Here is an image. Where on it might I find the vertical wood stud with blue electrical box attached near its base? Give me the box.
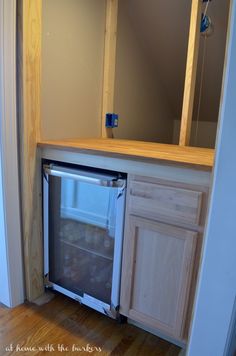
[101,0,118,138]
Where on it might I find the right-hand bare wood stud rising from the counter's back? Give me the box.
[179,0,202,146]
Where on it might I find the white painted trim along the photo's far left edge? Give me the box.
[0,0,24,307]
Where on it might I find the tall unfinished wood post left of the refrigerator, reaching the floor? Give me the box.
[17,0,44,301]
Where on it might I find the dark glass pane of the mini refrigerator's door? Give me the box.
[49,176,117,304]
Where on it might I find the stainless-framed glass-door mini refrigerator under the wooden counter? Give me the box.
[43,162,126,318]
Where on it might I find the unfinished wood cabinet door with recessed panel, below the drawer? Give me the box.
[121,215,197,339]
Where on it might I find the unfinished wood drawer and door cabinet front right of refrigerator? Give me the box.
[120,176,206,341]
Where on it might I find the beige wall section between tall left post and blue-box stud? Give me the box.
[41,0,106,139]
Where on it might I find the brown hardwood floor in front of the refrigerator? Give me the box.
[0,295,180,356]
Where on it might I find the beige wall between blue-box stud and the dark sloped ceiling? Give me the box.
[113,0,173,142]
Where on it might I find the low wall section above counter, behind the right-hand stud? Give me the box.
[172,120,217,148]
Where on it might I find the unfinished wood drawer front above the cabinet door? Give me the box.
[129,180,203,225]
